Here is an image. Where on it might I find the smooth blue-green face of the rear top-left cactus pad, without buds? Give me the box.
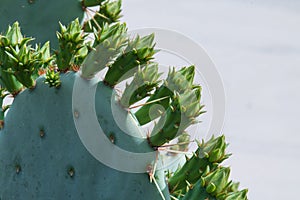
[0,0,84,49]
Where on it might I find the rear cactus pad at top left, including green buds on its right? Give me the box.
[0,0,121,47]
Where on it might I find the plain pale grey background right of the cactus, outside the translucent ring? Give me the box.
[123,0,300,200]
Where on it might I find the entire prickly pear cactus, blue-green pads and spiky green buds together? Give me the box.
[0,0,247,200]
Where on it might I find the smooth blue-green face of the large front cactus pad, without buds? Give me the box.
[0,73,170,200]
